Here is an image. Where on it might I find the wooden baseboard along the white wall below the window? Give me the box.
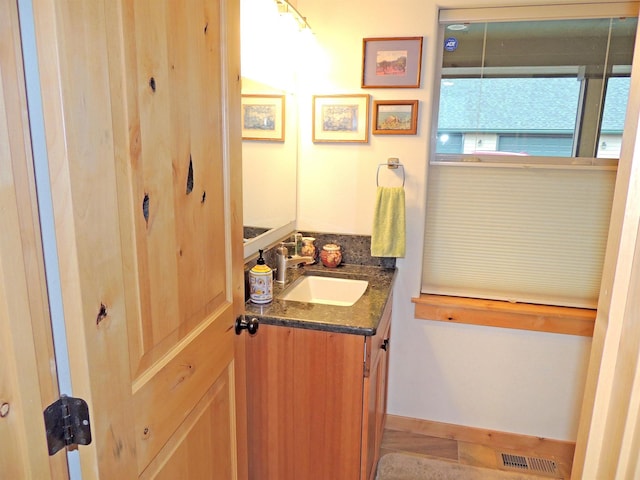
[385,414,575,465]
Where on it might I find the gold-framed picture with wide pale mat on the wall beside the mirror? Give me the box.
[312,94,370,143]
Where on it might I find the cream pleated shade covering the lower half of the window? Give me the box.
[422,162,616,308]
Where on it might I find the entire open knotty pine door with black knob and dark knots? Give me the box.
[33,0,246,479]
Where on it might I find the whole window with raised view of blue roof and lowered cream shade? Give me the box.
[422,4,637,308]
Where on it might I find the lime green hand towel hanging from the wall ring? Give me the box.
[371,187,405,257]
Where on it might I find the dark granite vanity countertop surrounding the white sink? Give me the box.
[245,264,396,335]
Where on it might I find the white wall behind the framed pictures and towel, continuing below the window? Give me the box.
[297,0,608,440]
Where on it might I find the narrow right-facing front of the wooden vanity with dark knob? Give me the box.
[360,301,392,480]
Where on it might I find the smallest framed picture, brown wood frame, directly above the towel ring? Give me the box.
[372,100,418,135]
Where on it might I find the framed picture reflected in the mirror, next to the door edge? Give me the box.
[242,95,285,142]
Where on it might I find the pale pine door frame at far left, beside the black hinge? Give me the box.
[0,0,67,480]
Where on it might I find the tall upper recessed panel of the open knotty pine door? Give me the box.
[125,0,227,375]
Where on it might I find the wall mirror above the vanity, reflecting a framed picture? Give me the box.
[240,0,308,258]
